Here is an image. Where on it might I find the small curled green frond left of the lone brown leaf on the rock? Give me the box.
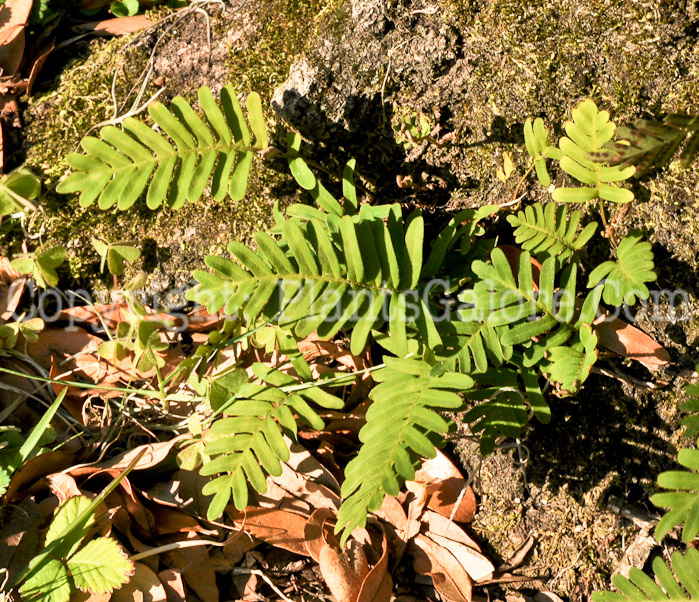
[541,324,597,393]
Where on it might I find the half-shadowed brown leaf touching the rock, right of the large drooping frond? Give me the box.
[414,450,476,523]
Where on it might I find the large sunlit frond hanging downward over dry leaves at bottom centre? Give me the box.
[335,358,473,541]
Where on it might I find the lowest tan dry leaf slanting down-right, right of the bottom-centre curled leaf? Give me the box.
[409,534,473,602]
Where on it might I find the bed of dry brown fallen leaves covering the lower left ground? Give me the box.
[0,247,676,602]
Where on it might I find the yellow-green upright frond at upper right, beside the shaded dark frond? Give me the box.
[553,100,635,203]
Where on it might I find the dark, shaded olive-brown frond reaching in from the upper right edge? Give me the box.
[593,113,699,177]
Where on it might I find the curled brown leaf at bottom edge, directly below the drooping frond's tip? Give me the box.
[318,539,369,602]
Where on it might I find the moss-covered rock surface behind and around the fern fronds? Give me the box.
[12,0,699,601]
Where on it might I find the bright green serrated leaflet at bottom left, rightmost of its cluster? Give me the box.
[68,537,134,594]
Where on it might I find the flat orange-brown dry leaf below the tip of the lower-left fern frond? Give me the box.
[226,505,309,556]
